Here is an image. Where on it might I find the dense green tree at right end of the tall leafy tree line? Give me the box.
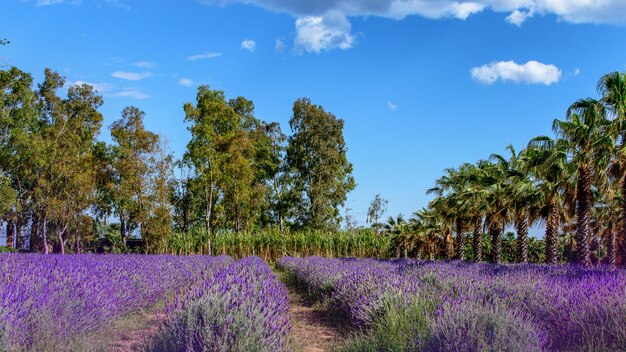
[287,98,356,229]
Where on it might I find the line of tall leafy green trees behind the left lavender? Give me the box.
[0,67,356,254]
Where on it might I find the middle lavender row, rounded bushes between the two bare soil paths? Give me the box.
[149,257,291,352]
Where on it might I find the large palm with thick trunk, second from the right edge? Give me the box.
[553,98,613,265]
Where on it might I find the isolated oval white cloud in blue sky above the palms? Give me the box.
[470,61,562,86]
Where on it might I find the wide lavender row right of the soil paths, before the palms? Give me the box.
[280,257,626,351]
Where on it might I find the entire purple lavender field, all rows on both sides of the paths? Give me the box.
[0,254,626,352]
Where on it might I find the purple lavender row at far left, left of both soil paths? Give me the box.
[0,254,233,351]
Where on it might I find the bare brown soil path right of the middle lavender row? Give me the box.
[276,271,349,352]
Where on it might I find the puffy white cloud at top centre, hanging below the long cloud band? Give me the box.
[294,12,355,53]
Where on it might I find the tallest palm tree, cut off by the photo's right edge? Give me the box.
[598,72,626,264]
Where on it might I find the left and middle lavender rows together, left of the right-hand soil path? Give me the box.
[0,254,290,351]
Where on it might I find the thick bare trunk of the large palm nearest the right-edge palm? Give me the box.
[576,167,591,266]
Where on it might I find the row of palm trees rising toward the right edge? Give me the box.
[388,72,626,266]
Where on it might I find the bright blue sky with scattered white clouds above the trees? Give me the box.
[0,0,626,228]
